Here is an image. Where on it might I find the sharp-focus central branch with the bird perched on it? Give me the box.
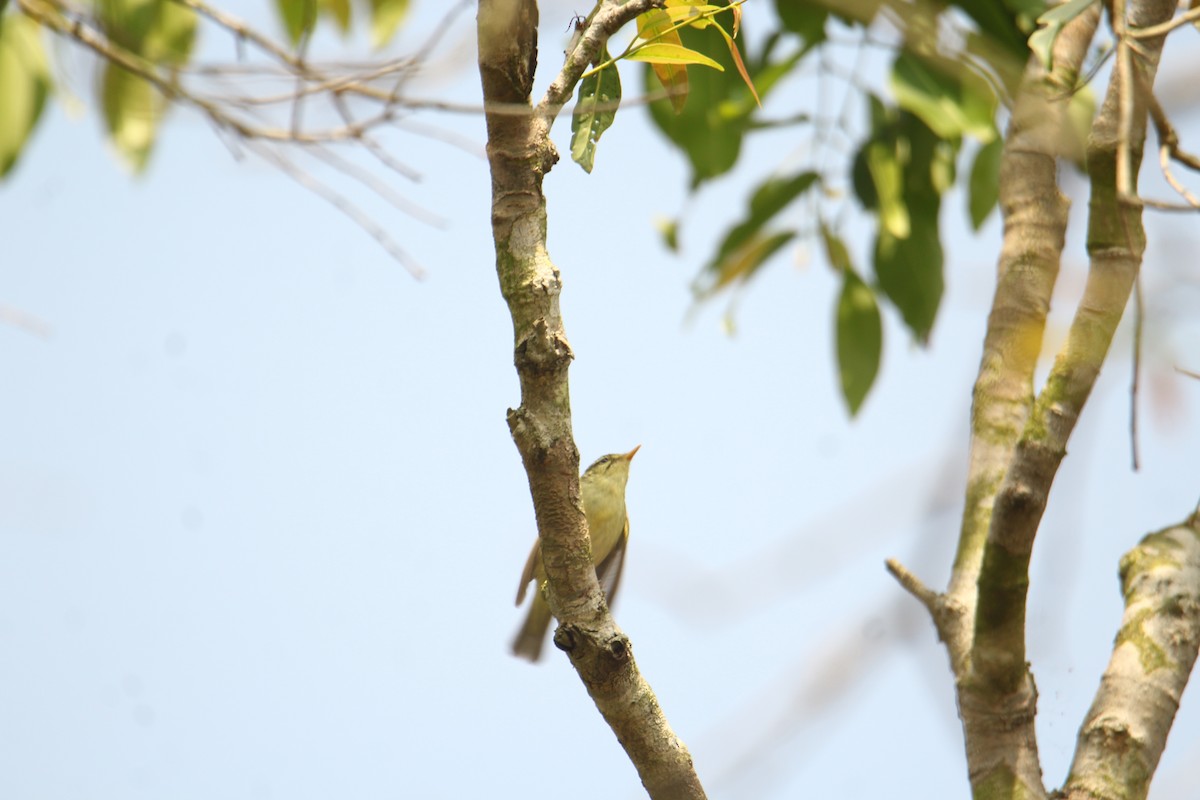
[478,0,704,800]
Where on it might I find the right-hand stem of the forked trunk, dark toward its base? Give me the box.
[973,0,1175,687]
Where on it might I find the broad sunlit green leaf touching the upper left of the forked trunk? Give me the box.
[892,50,997,144]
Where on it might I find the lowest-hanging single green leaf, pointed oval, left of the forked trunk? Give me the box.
[836,269,883,416]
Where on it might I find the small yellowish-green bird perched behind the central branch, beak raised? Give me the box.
[512,445,642,661]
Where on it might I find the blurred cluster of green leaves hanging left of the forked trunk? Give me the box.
[646,0,1060,414]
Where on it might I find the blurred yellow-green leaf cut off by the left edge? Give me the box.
[0,14,52,178]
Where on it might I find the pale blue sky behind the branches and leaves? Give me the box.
[0,0,1200,800]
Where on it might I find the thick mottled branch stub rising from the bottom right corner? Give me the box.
[1063,511,1200,800]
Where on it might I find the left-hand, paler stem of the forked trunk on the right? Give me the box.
[942,6,1100,674]
